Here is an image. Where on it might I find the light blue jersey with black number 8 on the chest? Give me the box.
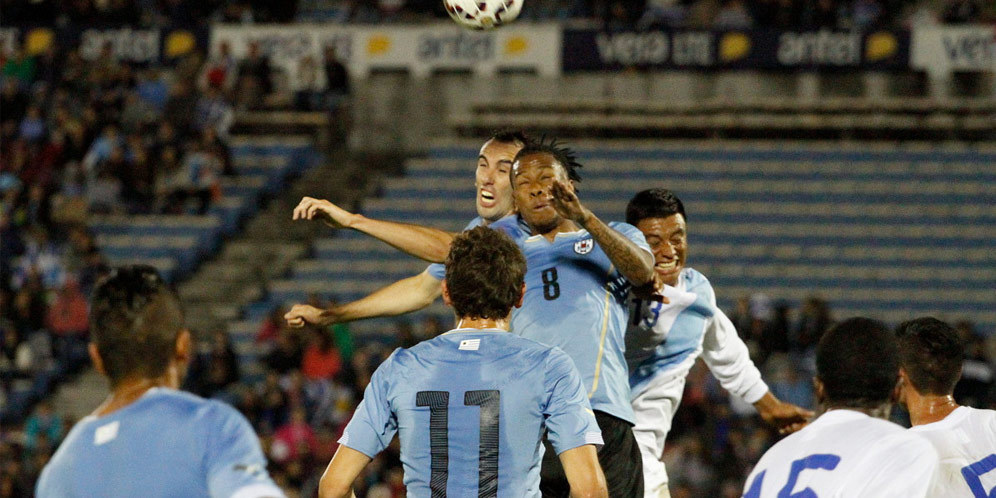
[491,216,650,423]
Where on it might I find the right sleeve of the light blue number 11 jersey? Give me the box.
[543,348,603,455]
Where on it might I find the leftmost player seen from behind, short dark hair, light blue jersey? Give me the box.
[36,265,284,498]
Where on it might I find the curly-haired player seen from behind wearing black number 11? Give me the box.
[319,227,608,498]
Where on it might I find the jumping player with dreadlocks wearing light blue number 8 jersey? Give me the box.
[491,140,654,496]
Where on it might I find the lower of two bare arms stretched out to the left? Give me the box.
[284,271,442,327]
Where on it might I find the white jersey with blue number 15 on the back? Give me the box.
[744,410,937,498]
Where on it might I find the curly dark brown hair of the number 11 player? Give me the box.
[446,227,526,319]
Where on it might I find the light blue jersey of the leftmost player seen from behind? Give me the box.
[36,388,283,498]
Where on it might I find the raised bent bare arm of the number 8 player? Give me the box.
[552,181,654,287]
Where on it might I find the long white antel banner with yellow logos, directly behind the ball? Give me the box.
[211,23,561,86]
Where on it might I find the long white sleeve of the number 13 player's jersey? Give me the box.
[702,308,768,403]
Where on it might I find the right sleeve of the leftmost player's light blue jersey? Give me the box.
[205,402,284,498]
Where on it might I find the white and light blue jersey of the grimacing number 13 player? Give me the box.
[626,268,768,403]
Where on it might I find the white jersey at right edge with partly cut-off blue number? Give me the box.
[910,406,996,498]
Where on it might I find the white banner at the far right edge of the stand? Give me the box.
[910,26,996,73]
